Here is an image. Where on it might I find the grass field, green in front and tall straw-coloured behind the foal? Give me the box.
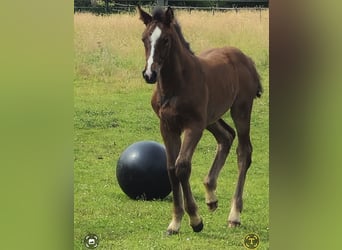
[74,8,269,250]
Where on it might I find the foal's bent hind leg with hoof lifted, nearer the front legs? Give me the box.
[204,119,235,212]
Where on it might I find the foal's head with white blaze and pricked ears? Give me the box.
[138,6,192,83]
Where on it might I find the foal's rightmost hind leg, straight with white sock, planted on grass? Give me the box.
[228,100,253,227]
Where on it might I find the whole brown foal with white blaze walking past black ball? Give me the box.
[138,7,262,234]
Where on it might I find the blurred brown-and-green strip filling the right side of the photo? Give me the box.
[270,0,342,249]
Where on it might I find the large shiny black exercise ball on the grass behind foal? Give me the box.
[116,141,171,200]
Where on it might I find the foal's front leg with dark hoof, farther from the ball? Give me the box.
[175,128,203,232]
